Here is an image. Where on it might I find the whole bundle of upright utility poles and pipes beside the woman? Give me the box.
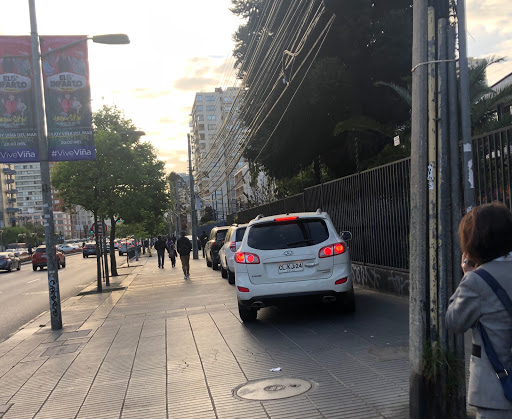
[409,0,466,418]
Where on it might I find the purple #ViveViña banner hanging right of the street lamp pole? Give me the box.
[40,36,96,161]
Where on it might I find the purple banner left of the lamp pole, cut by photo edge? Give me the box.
[0,36,39,163]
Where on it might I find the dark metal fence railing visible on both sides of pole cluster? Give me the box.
[228,126,512,270]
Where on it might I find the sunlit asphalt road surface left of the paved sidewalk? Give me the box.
[0,253,102,342]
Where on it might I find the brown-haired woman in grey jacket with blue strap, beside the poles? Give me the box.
[446,203,512,419]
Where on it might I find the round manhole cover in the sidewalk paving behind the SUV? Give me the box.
[233,377,313,401]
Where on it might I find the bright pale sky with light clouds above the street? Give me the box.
[0,0,512,173]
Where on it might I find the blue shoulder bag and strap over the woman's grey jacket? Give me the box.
[474,269,512,402]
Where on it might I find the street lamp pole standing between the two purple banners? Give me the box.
[28,0,62,330]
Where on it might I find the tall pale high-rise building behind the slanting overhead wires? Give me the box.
[190,87,243,219]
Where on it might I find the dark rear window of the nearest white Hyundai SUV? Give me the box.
[247,218,329,250]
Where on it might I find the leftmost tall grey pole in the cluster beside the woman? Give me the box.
[409,0,428,418]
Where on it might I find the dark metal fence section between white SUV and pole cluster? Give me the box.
[229,159,410,269]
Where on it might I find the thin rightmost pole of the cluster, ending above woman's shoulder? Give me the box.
[457,0,475,213]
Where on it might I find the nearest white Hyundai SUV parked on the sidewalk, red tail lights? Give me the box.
[235,210,355,321]
